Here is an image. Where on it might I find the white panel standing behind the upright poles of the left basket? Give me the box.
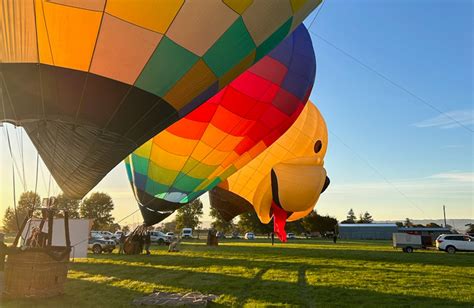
[21,218,92,258]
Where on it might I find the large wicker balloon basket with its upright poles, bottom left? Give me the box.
[3,210,71,298]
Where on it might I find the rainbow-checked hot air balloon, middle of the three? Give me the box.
[126,25,316,225]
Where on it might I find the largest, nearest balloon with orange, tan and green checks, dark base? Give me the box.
[0,0,320,198]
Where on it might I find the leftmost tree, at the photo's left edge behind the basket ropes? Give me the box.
[3,191,41,232]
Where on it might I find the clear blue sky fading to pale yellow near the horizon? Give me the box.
[0,0,474,223]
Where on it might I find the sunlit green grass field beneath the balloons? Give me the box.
[0,240,474,307]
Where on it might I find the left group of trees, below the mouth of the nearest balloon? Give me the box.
[3,191,115,232]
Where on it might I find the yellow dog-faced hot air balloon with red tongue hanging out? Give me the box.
[209,103,329,241]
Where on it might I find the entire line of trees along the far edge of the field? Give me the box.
[3,191,344,234]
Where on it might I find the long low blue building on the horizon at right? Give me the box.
[339,223,398,240]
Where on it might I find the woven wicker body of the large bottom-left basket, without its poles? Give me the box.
[4,247,69,298]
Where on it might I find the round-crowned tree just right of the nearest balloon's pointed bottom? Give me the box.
[79,192,114,230]
